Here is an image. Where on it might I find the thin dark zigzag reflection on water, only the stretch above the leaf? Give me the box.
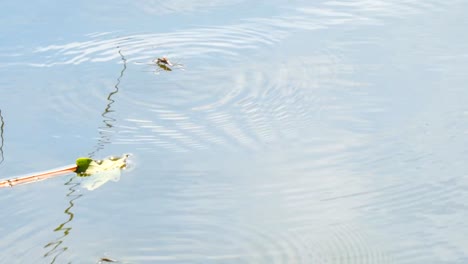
[88,49,127,157]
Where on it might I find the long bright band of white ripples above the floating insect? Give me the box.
[30,1,454,66]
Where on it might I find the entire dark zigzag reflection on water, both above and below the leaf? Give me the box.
[43,47,127,264]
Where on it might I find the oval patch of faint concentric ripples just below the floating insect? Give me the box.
[110,55,348,151]
